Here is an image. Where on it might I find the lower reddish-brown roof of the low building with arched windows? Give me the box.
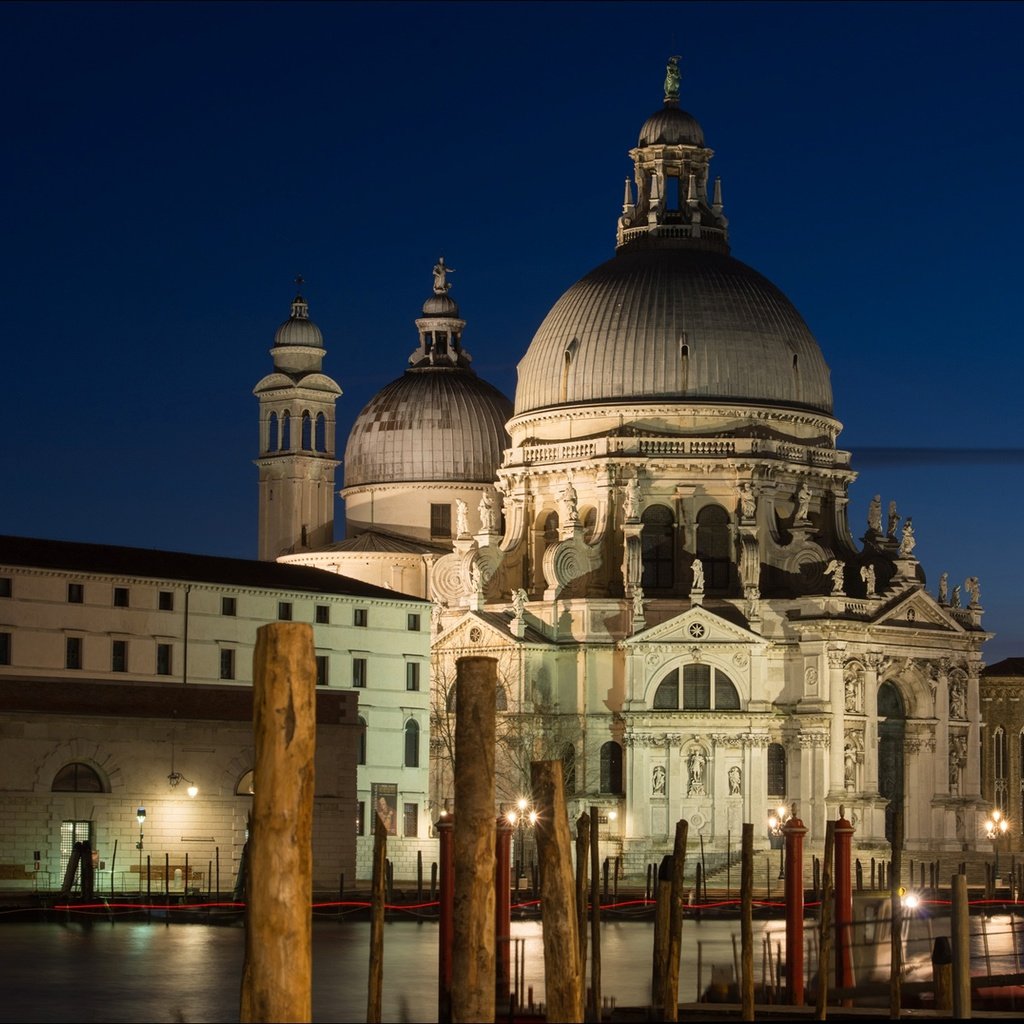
[0,676,358,725]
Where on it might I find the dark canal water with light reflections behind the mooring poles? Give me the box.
[0,916,1021,1022]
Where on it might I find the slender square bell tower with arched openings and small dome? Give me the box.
[253,278,341,560]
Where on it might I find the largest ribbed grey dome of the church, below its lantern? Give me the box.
[515,245,833,415]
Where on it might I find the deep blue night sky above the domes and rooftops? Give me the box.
[0,3,1024,662]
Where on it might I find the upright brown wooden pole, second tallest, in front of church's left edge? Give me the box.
[452,657,498,1024]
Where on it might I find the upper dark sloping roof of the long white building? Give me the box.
[0,536,422,601]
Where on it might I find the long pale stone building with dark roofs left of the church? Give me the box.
[0,537,430,891]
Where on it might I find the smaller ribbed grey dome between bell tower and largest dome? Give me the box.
[344,366,512,487]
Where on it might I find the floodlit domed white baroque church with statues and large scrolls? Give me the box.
[285,63,987,870]
